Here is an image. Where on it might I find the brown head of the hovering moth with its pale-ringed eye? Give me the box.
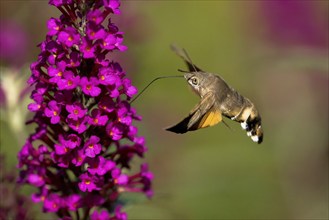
[184,72,213,97]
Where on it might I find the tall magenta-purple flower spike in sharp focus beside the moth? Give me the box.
[18,0,153,220]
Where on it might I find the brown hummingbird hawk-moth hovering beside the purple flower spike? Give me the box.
[166,46,263,144]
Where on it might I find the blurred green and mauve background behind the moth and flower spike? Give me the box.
[0,0,329,219]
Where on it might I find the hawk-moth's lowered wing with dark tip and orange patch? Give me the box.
[166,93,222,134]
